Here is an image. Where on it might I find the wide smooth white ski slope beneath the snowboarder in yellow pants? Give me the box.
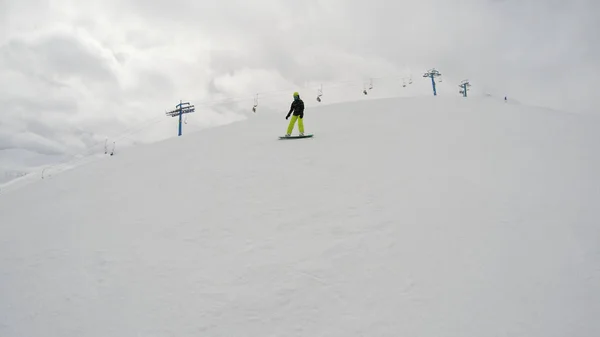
[0,97,600,337]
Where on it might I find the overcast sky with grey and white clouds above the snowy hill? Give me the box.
[0,0,600,182]
